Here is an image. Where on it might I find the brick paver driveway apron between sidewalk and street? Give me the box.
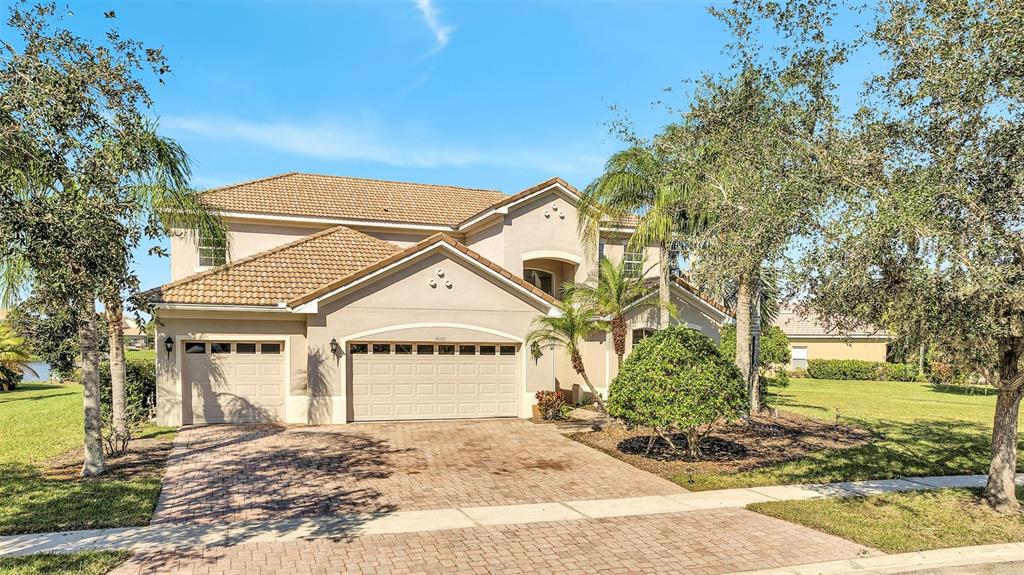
[111,510,878,575]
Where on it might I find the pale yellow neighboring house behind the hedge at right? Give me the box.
[775,306,891,369]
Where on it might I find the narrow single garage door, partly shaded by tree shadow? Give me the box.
[181,341,285,424]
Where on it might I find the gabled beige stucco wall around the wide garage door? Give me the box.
[306,250,551,423]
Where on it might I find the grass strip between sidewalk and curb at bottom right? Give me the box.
[748,488,1024,554]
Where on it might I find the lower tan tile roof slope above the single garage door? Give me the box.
[144,226,398,306]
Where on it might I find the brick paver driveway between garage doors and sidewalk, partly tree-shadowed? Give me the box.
[153,419,684,524]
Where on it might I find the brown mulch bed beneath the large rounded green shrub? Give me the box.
[568,413,872,478]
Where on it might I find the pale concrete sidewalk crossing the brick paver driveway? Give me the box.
[0,475,1024,557]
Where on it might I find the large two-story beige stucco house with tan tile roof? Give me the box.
[150,174,728,426]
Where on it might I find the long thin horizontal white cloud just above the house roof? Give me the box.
[161,117,604,175]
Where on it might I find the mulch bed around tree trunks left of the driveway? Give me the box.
[43,437,174,481]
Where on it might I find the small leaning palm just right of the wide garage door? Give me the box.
[526,292,607,412]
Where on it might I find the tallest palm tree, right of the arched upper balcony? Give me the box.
[577,145,694,327]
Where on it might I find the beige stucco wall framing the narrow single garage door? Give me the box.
[149,309,306,426]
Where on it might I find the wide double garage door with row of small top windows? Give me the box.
[348,342,520,422]
